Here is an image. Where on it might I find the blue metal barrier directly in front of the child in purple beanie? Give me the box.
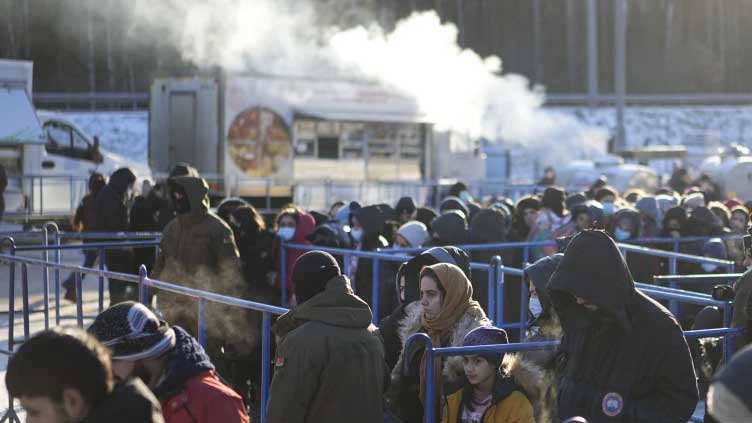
[404,327,739,423]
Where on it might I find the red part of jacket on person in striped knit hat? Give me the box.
[162,371,250,423]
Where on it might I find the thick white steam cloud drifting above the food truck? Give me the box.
[132,0,607,167]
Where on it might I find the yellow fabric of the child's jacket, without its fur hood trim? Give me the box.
[441,389,535,423]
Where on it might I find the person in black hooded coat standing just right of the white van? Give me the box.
[95,168,138,304]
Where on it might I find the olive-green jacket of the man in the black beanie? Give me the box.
[267,276,388,423]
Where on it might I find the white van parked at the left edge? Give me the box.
[0,60,151,220]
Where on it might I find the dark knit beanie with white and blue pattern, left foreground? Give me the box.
[89,301,175,361]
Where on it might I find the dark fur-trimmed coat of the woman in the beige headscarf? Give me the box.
[386,304,491,423]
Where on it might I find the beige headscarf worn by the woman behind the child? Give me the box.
[420,263,479,404]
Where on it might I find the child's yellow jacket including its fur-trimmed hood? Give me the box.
[441,354,542,423]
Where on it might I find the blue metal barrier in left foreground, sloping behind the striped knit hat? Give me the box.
[0,254,288,423]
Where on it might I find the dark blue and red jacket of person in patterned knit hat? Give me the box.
[154,326,249,423]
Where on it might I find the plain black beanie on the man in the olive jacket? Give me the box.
[292,251,342,304]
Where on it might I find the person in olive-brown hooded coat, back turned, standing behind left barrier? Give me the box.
[154,176,253,380]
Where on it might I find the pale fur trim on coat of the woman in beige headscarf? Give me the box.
[392,301,491,383]
